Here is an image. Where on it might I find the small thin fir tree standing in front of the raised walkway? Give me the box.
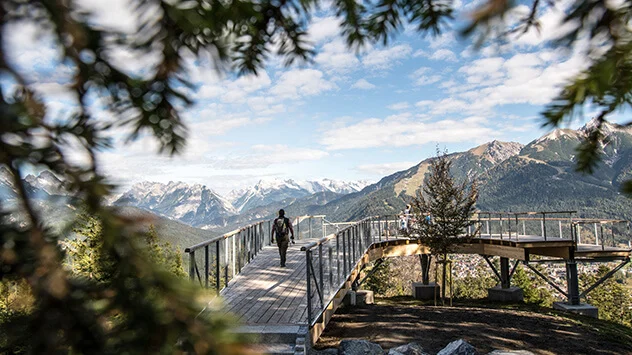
[408,151,478,301]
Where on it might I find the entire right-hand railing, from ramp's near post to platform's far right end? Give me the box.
[301,211,632,326]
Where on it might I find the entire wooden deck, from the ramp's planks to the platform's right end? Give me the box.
[215,235,630,332]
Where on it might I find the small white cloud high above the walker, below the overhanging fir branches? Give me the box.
[270,69,338,99]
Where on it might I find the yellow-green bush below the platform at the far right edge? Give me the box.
[579,265,632,327]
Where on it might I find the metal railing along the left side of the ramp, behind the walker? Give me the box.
[184,215,325,293]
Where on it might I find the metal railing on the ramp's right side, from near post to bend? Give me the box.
[301,216,399,325]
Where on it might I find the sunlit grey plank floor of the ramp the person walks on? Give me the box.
[221,238,318,325]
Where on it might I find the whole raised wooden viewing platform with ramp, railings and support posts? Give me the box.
[186,211,632,350]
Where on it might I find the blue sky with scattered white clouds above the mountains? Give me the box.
[0,0,623,194]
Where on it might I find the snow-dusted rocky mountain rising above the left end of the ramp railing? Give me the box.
[114,181,237,228]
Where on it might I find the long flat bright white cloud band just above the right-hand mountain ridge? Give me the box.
[320,116,495,150]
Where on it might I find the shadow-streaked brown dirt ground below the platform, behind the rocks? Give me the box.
[315,298,632,355]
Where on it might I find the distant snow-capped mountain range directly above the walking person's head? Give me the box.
[230,179,368,212]
